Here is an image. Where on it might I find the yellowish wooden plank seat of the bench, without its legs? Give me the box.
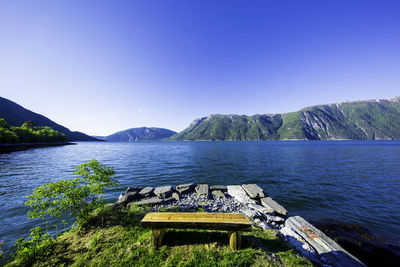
[141,212,252,231]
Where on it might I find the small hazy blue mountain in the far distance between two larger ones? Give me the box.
[106,127,176,142]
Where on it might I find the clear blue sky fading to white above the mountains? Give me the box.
[0,0,400,135]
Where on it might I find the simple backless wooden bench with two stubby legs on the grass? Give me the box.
[141,212,252,250]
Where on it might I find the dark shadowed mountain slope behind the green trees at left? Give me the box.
[0,97,97,141]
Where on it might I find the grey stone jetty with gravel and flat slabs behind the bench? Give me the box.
[115,183,365,266]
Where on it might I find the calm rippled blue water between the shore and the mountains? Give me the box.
[0,141,400,256]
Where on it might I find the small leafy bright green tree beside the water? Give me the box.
[25,159,117,223]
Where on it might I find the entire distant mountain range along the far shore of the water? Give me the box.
[0,97,400,142]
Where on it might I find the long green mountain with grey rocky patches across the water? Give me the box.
[170,97,400,140]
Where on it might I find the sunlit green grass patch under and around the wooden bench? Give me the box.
[6,206,311,267]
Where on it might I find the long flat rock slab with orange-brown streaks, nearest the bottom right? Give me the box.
[281,216,365,266]
